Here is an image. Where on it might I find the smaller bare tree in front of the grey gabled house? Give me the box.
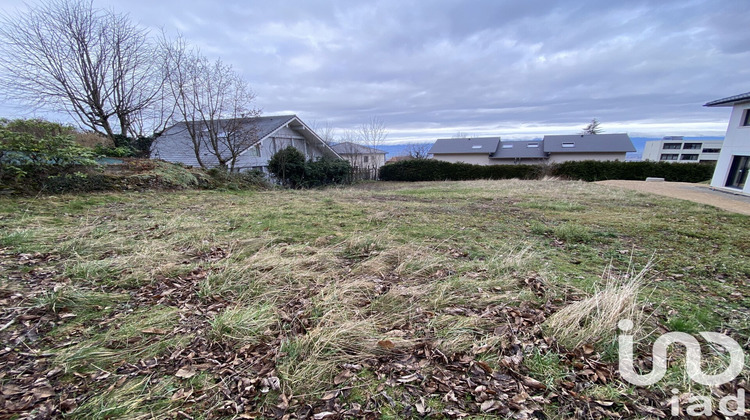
[163,38,260,171]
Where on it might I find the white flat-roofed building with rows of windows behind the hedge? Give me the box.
[642,136,724,163]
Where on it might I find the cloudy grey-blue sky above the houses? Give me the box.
[0,0,750,143]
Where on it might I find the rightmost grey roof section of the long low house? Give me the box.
[544,133,635,153]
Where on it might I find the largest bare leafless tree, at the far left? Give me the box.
[0,0,163,138]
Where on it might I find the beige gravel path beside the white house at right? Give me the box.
[597,180,750,216]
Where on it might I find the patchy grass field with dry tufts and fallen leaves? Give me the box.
[0,180,750,419]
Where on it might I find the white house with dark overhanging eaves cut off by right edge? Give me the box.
[705,92,750,194]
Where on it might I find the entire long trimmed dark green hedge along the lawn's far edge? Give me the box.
[380,159,715,182]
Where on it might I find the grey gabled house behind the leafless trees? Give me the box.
[151,115,341,172]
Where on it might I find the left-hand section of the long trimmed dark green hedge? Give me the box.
[380,159,544,181]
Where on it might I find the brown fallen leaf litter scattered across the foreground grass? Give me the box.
[0,206,745,419]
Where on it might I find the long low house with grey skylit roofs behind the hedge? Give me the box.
[429,134,635,165]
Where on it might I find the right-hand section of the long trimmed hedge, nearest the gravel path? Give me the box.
[552,160,716,182]
